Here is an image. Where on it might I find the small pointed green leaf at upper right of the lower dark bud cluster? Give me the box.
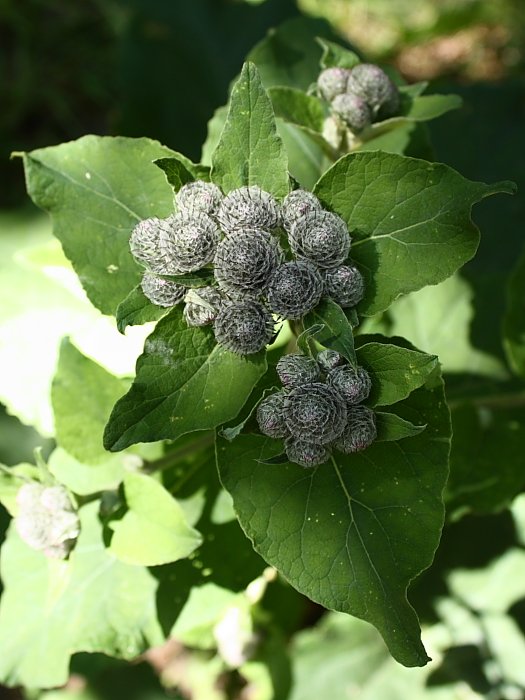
[356,336,438,406]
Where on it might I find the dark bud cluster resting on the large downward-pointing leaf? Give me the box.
[257,350,377,467]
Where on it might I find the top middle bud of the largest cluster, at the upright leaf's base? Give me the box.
[217,185,280,234]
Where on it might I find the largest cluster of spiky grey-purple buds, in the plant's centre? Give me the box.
[130,180,364,355]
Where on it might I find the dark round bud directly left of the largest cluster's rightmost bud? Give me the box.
[267,260,323,320]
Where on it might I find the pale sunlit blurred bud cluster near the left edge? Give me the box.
[15,482,80,559]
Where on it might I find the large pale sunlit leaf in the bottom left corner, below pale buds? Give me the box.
[0,503,164,688]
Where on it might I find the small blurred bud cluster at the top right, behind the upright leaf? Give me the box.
[317,63,400,140]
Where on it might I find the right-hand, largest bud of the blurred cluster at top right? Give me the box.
[346,63,399,120]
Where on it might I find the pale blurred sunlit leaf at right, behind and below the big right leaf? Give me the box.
[385,275,507,379]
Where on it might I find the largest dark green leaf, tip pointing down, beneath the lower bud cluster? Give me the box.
[217,366,450,666]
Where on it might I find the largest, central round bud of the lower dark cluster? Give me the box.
[283,382,346,445]
